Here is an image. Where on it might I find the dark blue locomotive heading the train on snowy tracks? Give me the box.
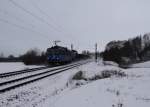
[46,45,77,64]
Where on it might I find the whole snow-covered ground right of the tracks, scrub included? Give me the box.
[0,61,150,107]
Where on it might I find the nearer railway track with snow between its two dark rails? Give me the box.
[0,61,90,93]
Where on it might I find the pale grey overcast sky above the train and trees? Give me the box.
[0,0,150,55]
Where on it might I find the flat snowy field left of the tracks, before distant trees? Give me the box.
[0,62,44,73]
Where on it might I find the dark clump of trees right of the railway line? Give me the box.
[101,36,150,64]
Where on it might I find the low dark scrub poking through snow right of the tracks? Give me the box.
[66,70,126,88]
